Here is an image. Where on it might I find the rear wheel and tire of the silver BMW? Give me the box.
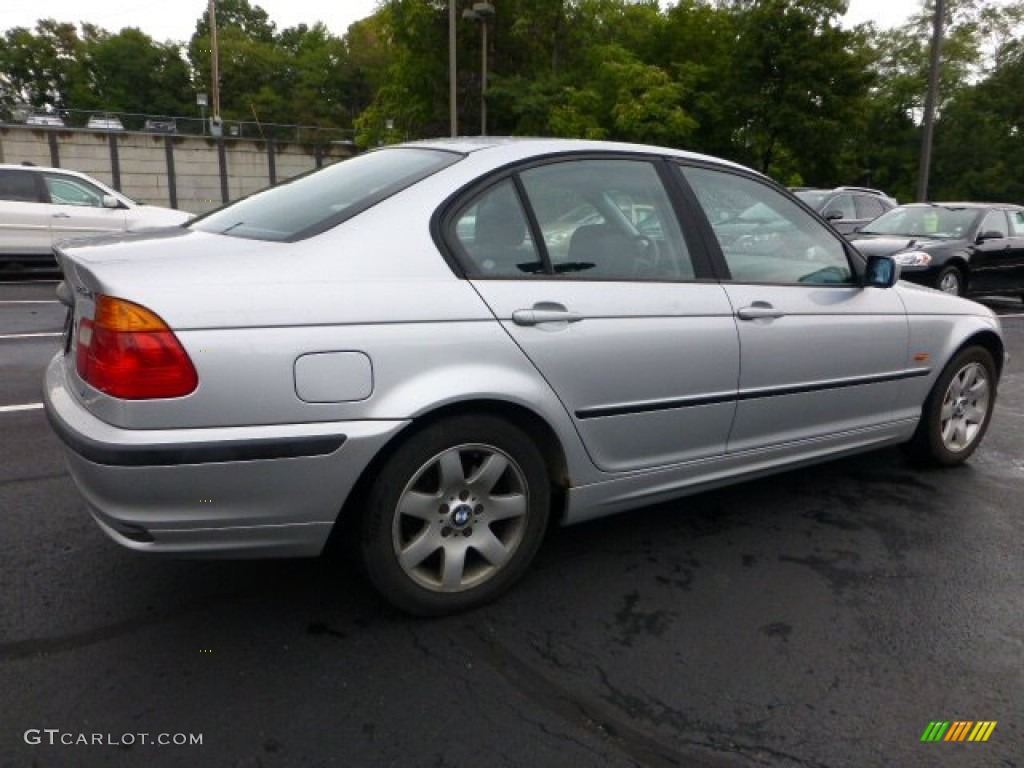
[360,415,551,616]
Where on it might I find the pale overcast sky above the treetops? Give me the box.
[0,0,923,42]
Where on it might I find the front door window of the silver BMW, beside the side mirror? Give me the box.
[682,167,855,285]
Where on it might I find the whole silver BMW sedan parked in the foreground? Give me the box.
[45,138,1004,614]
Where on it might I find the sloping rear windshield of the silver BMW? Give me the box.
[188,147,463,243]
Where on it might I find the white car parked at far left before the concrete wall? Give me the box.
[0,165,191,271]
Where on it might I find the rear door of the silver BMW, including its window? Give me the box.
[447,157,739,471]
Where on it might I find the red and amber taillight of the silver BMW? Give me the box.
[75,296,199,400]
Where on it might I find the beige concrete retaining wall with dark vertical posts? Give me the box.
[0,125,352,213]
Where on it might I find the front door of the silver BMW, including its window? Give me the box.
[680,166,909,453]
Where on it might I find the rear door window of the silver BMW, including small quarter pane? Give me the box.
[453,158,694,281]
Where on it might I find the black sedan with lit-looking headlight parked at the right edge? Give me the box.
[851,203,1024,298]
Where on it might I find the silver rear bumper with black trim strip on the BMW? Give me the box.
[44,354,406,557]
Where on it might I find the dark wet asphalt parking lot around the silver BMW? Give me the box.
[0,282,1024,768]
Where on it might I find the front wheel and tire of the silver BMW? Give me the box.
[906,346,996,467]
